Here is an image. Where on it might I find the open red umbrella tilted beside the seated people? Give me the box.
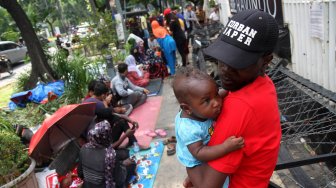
[29,103,96,161]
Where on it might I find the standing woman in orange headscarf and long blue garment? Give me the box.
[151,21,176,75]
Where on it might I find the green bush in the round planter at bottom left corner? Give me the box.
[0,129,30,185]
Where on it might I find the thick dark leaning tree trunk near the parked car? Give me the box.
[0,0,55,89]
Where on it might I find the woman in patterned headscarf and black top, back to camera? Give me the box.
[78,120,135,188]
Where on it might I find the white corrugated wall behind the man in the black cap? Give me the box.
[218,0,336,92]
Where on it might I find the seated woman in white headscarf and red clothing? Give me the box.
[125,55,149,87]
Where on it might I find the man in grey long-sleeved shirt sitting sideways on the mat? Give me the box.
[111,63,149,109]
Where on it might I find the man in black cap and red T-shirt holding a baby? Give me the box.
[188,9,281,188]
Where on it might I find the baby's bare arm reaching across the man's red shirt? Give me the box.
[188,136,244,162]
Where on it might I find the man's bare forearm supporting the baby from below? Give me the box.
[187,163,228,188]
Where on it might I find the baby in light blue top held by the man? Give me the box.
[173,67,244,185]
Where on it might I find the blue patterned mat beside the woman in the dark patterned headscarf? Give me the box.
[129,141,164,188]
